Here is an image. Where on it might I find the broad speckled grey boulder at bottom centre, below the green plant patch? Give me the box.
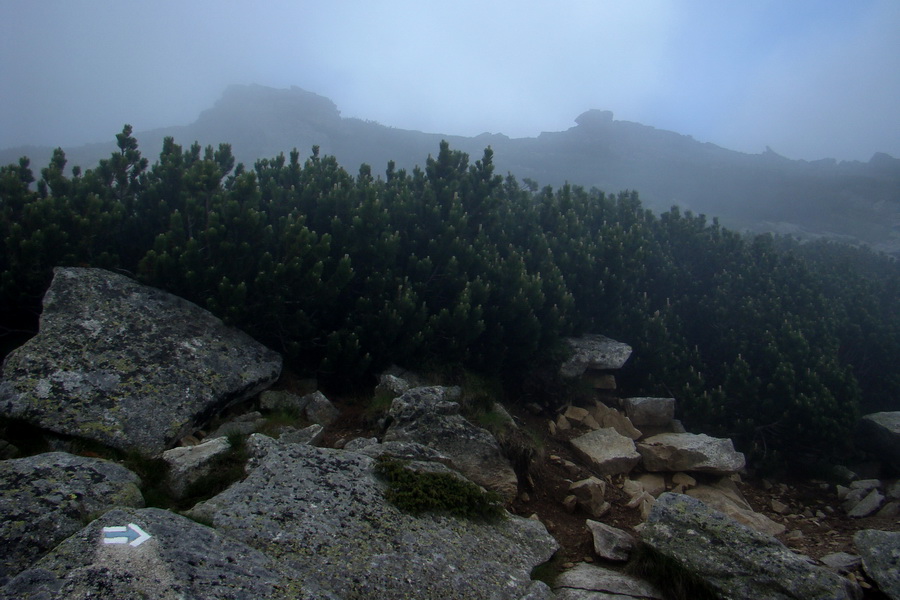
[192,435,558,600]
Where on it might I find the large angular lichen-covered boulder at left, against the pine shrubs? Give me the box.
[0,268,281,455]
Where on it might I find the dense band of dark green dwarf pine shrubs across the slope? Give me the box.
[0,126,900,458]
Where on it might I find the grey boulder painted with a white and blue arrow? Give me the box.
[0,508,302,600]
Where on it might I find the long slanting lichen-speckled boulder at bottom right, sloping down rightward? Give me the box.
[641,493,858,600]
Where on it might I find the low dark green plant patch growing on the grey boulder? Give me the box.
[375,457,504,520]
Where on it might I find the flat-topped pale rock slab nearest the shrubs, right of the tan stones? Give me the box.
[637,433,744,475]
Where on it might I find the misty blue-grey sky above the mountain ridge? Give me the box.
[0,0,900,160]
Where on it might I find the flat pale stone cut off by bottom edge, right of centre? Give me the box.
[553,563,664,600]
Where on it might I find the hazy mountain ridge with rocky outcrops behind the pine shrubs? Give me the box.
[0,85,900,255]
